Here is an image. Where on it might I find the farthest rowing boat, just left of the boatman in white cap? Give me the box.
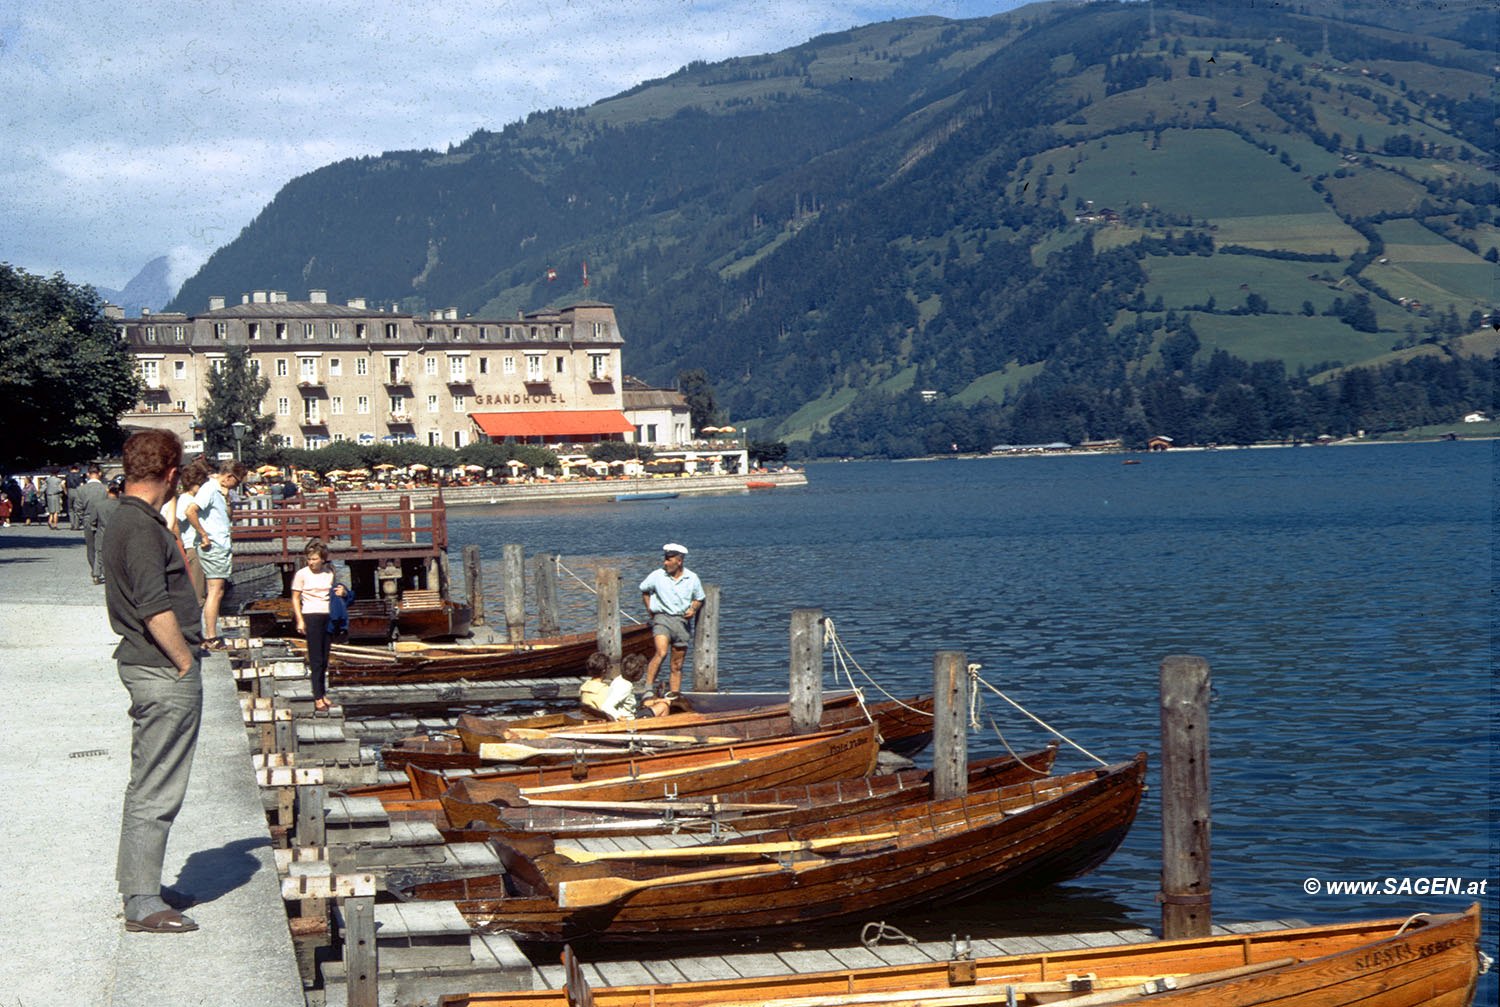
[329,626,654,686]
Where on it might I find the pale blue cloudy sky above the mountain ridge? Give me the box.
[0,0,1020,295]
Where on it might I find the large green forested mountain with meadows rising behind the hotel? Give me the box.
[171,0,1500,450]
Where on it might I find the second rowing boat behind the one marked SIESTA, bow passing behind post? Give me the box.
[440,741,1058,842]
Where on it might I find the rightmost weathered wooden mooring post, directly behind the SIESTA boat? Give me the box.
[1157,654,1214,939]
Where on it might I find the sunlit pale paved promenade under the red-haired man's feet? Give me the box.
[0,522,305,1007]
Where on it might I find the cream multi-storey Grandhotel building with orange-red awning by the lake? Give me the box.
[108,290,692,447]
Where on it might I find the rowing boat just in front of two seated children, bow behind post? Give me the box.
[381,695,933,768]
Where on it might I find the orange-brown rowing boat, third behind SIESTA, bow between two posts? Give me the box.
[344,725,878,816]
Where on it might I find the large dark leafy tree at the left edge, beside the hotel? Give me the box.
[0,263,141,468]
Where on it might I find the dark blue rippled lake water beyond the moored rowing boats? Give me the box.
[450,443,1500,978]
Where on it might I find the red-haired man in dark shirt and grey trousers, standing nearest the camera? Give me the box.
[101,429,203,933]
